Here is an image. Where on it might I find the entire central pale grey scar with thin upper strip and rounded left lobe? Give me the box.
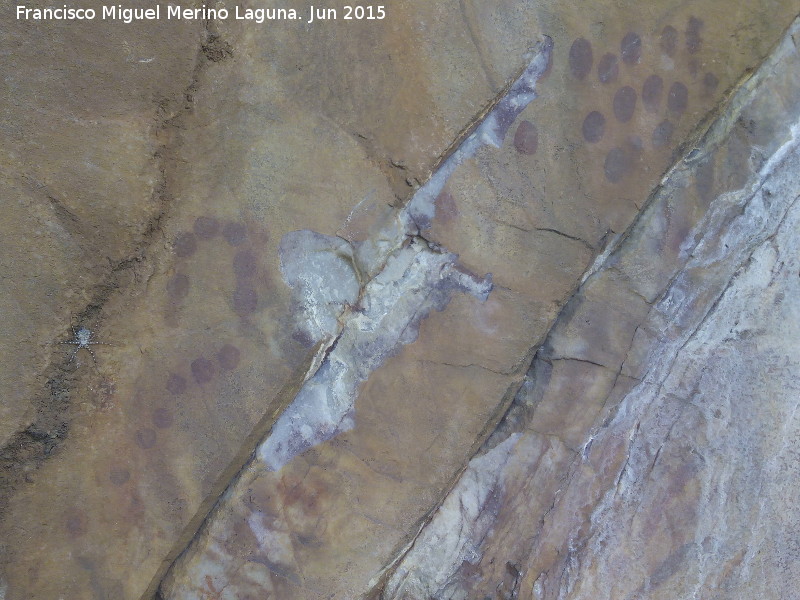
[266,38,553,470]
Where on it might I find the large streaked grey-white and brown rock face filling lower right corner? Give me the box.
[381,16,800,599]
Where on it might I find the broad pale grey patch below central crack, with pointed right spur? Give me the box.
[257,240,492,470]
